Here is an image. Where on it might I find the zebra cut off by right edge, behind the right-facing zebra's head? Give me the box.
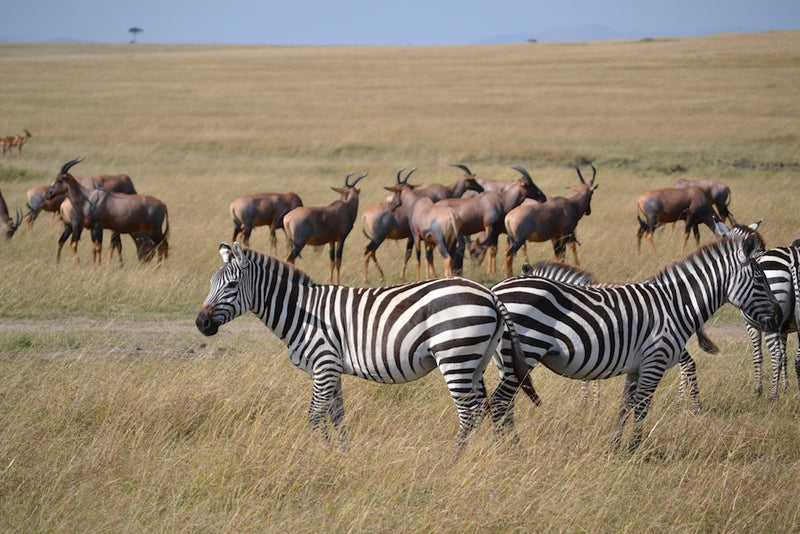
[742,246,800,400]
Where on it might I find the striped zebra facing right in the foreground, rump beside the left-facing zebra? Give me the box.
[491,225,780,448]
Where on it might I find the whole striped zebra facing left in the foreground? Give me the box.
[196,243,526,450]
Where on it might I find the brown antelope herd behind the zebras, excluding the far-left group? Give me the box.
[225,163,735,284]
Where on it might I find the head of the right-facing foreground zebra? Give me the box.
[727,230,783,332]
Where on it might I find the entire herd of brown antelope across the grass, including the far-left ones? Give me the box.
[0,153,735,276]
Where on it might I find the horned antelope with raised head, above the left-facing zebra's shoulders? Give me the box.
[283,172,367,284]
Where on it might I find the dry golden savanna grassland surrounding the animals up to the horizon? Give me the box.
[0,32,800,533]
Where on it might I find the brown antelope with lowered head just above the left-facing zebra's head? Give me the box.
[230,192,303,251]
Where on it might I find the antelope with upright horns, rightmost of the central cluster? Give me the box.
[503,165,597,276]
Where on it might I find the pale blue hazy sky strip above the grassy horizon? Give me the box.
[0,0,800,45]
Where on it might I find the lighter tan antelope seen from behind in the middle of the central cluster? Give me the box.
[385,181,460,281]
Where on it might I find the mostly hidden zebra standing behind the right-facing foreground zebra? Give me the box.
[522,260,719,413]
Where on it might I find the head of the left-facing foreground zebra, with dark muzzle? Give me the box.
[195,242,252,336]
